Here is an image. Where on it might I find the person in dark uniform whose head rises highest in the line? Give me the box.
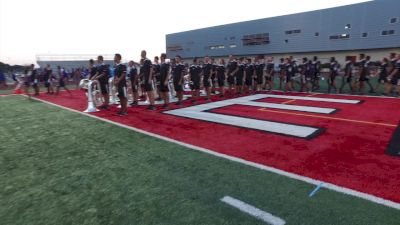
[140,50,156,110]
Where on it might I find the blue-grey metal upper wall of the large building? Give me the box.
[166,0,400,58]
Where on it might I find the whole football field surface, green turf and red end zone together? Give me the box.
[0,92,400,225]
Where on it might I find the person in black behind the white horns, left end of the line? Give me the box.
[92,55,110,109]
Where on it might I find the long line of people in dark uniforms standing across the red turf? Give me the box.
[89,51,400,115]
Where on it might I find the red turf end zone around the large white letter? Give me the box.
[35,92,400,203]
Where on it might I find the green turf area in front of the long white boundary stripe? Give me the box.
[0,96,400,225]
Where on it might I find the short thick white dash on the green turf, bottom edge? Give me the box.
[221,196,286,225]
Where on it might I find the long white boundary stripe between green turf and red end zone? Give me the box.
[32,97,400,210]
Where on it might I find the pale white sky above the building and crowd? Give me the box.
[0,0,366,64]
